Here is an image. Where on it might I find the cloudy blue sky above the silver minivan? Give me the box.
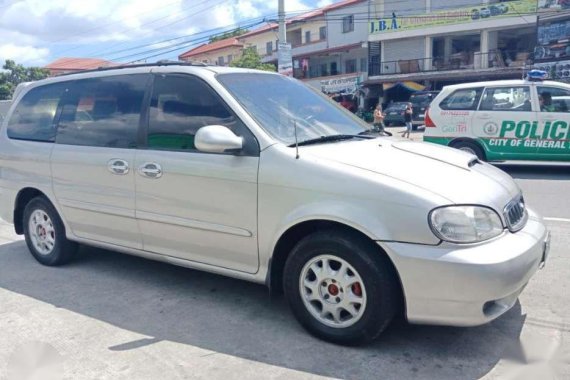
[0,0,338,66]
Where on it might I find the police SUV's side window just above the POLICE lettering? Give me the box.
[479,86,532,112]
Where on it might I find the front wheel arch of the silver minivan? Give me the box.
[267,219,406,312]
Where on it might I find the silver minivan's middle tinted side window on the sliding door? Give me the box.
[56,74,148,148]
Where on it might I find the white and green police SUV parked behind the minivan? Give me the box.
[424,71,570,161]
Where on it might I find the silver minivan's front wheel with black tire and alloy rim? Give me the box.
[283,229,400,345]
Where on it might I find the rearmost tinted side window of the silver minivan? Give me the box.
[8,82,69,142]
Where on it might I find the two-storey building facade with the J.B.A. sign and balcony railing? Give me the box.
[367,0,537,100]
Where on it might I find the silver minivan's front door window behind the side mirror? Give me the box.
[147,75,259,155]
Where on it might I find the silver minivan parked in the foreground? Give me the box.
[0,63,549,344]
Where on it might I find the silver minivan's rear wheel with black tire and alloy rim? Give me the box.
[23,197,77,266]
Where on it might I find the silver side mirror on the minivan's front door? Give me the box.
[194,125,243,153]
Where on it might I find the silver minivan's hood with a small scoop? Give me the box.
[300,138,520,208]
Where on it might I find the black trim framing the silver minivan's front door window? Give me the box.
[137,72,261,157]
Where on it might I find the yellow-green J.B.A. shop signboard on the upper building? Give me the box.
[369,0,537,34]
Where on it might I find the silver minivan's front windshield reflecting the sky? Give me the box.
[217,73,369,145]
